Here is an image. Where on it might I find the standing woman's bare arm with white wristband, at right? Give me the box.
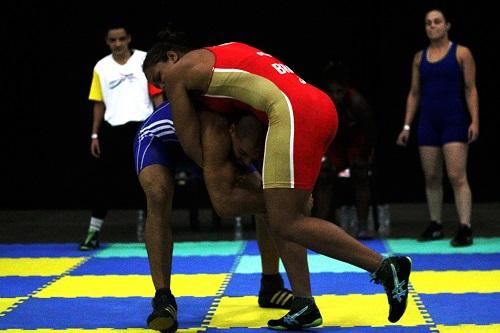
[397,51,423,146]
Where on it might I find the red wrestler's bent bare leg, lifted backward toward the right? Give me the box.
[264,188,382,272]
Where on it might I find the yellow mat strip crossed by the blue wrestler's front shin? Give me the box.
[33,274,227,298]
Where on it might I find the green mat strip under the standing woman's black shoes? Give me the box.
[385,237,500,254]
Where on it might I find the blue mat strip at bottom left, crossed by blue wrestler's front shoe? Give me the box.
[0,297,213,329]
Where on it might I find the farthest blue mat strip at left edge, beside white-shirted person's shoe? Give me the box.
[0,243,91,258]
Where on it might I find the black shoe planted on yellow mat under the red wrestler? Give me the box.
[267,297,323,331]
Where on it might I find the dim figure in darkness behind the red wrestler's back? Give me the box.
[315,61,376,239]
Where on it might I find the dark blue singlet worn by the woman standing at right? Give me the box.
[418,43,470,147]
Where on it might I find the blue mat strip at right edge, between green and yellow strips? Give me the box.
[410,254,500,272]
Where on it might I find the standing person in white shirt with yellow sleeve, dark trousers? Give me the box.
[79,24,163,251]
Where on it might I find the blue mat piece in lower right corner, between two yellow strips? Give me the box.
[420,293,500,325]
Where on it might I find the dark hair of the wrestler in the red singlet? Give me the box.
[142,25,192,70]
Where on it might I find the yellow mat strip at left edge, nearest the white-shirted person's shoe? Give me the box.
[0,258,86,276]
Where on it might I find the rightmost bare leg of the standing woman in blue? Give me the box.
[443,142,472,226]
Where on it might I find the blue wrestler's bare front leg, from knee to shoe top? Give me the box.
[139,165,174,290]
